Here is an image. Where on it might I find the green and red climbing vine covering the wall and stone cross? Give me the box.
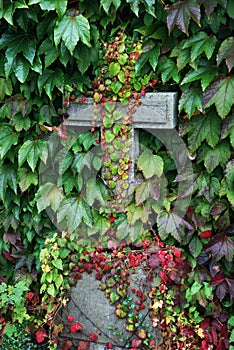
[0,0,234,350]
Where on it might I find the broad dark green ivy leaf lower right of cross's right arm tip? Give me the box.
[183,111,221,152]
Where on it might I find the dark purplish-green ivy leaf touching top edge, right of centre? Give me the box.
[167,0,201,35]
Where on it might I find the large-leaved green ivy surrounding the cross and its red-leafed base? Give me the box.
[0,0,234,350]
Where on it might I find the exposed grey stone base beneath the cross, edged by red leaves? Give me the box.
[55,268,161,350]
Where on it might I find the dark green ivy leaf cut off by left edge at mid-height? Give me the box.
[0,164,17,201]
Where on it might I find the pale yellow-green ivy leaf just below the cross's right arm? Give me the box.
[137,150,163,179]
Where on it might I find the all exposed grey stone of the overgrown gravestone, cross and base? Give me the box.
[55,92,177,350]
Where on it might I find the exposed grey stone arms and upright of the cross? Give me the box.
[65,92,177,208]
